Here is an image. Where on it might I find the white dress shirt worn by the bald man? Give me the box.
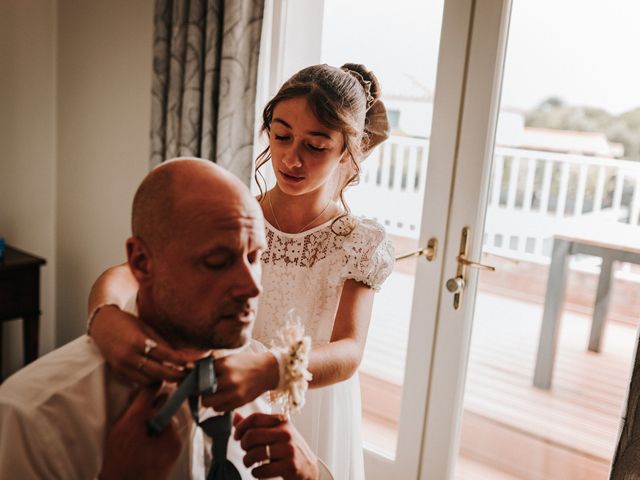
[0,296,269,480]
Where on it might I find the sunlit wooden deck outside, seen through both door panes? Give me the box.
[362,275,636,480]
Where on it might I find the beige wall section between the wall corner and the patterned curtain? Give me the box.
[56,0,153,344]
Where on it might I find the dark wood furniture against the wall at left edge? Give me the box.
[0,245,46,376]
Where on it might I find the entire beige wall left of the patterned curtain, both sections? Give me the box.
[0,0,153,375]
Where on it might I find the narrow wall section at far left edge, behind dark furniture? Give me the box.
[0,0,56,375]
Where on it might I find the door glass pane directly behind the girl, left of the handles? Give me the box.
[322,0,443,457]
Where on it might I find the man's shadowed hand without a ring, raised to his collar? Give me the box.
[99,387,182,480]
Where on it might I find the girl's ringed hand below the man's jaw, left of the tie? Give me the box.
[90,305,187,385]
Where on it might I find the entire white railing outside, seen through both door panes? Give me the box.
[347,137,640,279]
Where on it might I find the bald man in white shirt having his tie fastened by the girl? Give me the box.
[0,159,322,480]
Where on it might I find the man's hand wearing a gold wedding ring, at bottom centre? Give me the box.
[233,413,319,480]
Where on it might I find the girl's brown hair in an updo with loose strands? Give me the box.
[255,63,389,223]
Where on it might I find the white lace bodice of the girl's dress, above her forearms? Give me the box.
[253,216,393,345]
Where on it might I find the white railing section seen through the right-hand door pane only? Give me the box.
[484,148,640,261]
